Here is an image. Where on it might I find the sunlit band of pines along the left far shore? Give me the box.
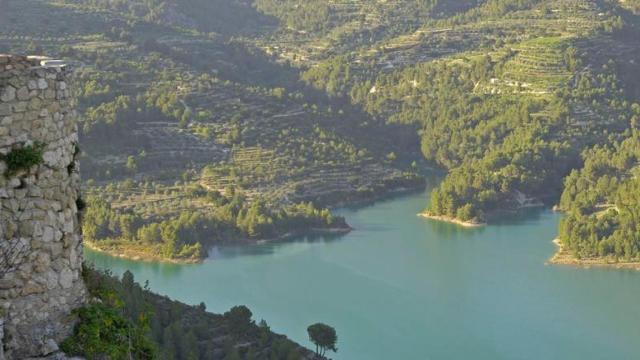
[82,188,349,261]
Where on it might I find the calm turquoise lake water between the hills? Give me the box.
[86,190,640,360]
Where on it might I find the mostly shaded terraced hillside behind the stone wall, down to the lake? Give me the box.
[0,0,423,262]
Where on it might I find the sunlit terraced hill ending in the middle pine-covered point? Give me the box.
[276,0,638,226]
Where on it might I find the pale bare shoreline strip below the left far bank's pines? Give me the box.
[82,225,353,265]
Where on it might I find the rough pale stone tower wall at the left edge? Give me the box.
[0,55,86,359]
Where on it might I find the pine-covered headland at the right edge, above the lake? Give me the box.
[560,133,640,261]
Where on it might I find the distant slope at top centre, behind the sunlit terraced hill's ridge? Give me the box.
[255,0,481,66]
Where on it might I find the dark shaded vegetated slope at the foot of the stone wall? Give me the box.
[62,268,323,360]
